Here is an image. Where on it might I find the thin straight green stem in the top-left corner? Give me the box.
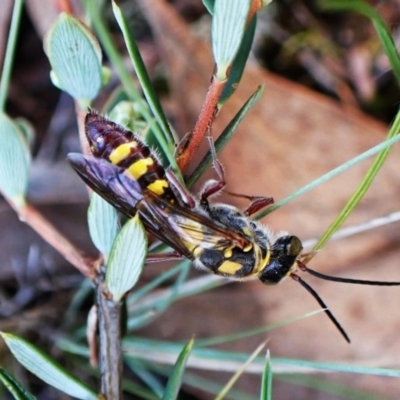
[0,0,24,112]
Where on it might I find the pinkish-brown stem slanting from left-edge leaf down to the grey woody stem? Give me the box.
[14,202,96,279]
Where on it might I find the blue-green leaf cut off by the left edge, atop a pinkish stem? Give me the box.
[0,113,31,208]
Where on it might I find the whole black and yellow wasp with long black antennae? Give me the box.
[68,110,400,341]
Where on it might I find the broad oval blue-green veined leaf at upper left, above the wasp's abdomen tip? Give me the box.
[44,13,103,104]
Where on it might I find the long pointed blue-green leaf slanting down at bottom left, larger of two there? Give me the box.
[1,332,97,400]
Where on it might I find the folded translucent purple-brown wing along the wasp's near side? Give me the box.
[68,153,249,259]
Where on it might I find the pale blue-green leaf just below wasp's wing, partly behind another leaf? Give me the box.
[88,193,118,261]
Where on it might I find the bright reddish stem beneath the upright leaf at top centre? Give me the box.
[177,76,226,173]
